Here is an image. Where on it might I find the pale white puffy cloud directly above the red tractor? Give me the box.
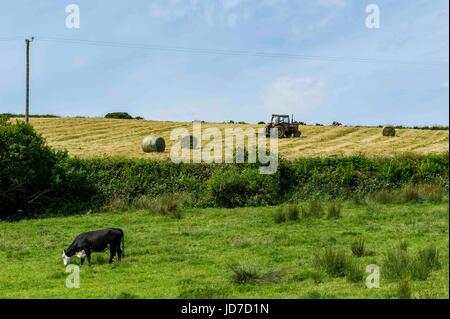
[263,77,325,116]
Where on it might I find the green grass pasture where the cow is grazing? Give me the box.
[0,203,449,298]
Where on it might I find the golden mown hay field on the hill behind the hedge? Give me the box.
[26,118,449,159]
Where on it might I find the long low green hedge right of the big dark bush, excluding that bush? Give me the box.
[68,154,449,212]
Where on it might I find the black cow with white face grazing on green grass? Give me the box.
[62,228,125,266]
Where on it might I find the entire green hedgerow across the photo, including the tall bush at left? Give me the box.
[0,121,449,219]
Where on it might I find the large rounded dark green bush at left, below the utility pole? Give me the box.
[0,118,91,219]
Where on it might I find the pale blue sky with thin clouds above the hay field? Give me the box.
[0,0,449,125]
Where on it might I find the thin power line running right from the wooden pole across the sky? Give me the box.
[30,36,448,66]
